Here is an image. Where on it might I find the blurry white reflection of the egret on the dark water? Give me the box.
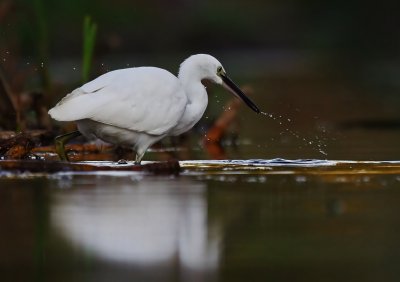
[51,177,220,281]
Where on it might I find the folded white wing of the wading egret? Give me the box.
[49,67,187,135]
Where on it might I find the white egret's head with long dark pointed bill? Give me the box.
[179,54,261,113]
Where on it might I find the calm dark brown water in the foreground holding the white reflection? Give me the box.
[0,159,400,281]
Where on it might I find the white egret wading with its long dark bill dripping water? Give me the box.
[49,54,260,164]
